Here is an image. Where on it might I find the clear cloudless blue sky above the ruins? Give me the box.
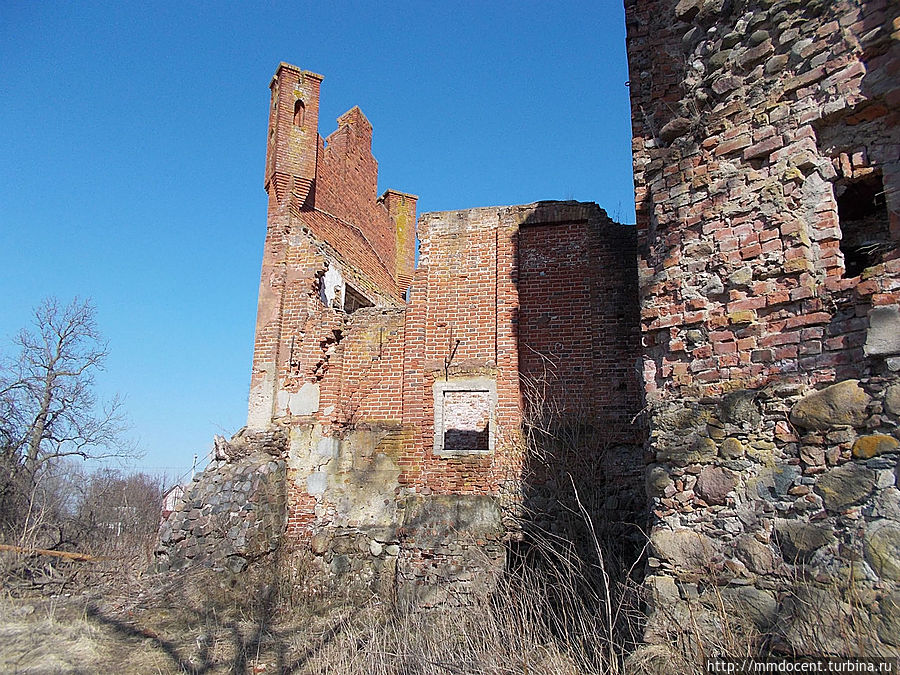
[0,0,634,478]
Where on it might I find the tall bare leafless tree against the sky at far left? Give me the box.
[0,298,135,540]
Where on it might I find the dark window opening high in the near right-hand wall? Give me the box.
[834,171,896,277]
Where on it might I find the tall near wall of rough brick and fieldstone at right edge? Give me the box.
[625,0,900,655]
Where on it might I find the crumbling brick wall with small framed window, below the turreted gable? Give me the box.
[275,202,640,602]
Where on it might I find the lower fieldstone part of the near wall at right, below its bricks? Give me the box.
[645,378,900,654]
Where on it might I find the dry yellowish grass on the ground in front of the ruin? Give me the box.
[0,532,648,675]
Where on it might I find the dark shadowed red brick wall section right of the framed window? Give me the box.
[518,219,641,440]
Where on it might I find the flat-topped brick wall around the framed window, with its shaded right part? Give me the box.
[404,202,640,494]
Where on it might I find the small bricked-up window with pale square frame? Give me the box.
[434,377,497,455]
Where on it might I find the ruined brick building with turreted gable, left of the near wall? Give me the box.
[156,63,640,602]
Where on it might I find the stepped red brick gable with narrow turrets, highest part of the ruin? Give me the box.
[248,64,416,428]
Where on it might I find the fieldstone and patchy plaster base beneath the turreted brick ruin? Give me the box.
[154,425,506,608]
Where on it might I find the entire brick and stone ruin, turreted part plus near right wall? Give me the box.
[161,0,900,654]
